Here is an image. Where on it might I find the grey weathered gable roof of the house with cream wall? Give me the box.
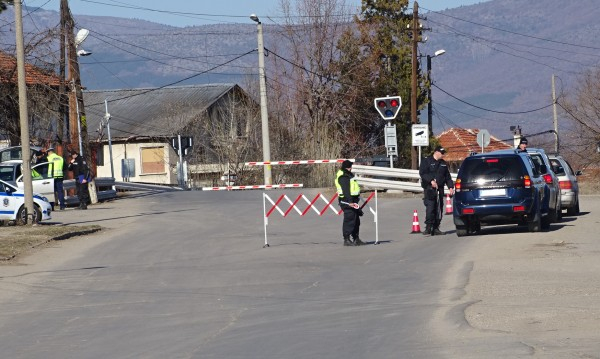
[83,84,244,140]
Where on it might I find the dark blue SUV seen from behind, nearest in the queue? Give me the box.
[453,150,547,237]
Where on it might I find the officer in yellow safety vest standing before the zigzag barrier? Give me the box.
[335,160,365,246]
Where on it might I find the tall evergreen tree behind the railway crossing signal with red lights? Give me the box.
[338,0,426,167]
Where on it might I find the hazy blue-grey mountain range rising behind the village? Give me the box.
[0,0,600,143]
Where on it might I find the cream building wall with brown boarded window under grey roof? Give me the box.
[96,142,178,185]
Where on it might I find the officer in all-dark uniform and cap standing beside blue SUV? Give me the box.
[419,146,454,235]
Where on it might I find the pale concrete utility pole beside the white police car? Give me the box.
[14,1,35,224]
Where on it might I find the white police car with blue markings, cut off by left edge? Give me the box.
[0,180,52,223]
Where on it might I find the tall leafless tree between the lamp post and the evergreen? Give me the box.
[269,0,358,186]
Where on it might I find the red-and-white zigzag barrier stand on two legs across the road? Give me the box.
[263,191,379,248]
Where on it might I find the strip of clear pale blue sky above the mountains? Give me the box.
[29,0,487,26]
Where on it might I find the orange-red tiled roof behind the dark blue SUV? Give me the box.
[437,128,513,162]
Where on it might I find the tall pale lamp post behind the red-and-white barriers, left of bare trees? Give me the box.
[250,14,272,185]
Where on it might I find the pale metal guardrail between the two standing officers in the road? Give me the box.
[352,165,456,193]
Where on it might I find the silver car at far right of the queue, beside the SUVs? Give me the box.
[548,155,581,216]
